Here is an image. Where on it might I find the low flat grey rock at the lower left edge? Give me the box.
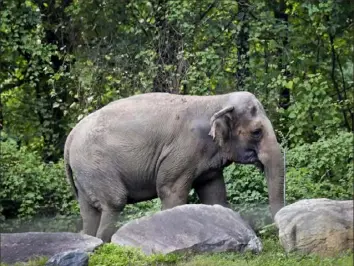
[1,232,102,263]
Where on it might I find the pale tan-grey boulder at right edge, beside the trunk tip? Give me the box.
[274,198,353,256]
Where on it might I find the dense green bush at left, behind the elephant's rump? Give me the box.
[0,135,78,218]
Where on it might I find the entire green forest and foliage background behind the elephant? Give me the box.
[0,0,354,227]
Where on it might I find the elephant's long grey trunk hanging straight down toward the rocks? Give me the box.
[258,119,284,218]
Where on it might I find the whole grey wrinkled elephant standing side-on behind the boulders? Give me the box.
[64,92,284,242]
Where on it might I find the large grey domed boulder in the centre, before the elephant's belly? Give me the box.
[112,204,262,255]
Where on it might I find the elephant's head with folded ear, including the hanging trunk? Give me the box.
[209,92,284,217]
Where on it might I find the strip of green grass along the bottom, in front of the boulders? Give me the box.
[0,238,353,266]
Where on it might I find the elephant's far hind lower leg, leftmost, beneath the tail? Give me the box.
[79,196,101,236]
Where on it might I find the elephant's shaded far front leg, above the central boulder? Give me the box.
[194,173,229,207]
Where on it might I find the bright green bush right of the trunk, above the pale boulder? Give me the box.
[287,132,354,202]
